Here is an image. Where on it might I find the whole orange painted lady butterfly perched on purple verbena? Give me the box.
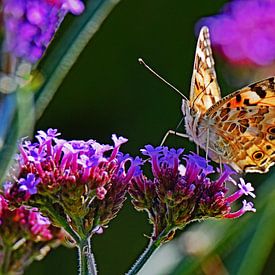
[182,27,275,173]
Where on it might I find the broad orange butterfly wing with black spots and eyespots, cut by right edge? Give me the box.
[206,77,275,173]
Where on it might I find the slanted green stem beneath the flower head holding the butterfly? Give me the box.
[127,228,171,275]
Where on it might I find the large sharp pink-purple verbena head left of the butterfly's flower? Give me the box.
[4,129,140,242]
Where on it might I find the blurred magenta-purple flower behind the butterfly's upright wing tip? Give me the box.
[198,0,275,66]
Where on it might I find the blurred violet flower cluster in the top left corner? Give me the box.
[3,0,84,63]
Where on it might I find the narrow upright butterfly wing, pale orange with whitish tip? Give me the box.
[190,27,221,114]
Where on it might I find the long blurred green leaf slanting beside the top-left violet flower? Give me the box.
[35,0,122,119]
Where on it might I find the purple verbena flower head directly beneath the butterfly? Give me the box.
[129,145,256,243]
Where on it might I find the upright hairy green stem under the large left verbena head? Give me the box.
[77,237,97,275]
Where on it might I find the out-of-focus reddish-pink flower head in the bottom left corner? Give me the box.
[0,195,65,274]
